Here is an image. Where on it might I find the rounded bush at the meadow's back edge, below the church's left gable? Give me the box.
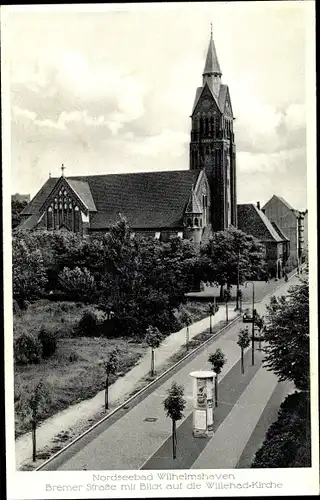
[59,267,97,303]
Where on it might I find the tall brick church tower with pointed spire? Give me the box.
[190,27,237,231]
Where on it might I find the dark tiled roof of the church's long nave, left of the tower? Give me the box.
[20,170,201,229]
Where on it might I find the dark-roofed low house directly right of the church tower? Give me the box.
[237,203,290,279]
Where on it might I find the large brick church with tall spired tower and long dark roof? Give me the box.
[19,29,237,245]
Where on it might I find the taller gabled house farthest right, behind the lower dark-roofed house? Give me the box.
[262,195,308,270]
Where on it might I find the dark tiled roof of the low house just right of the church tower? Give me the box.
[237,203,284,242]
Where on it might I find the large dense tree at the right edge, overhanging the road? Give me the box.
[263,277,310,391]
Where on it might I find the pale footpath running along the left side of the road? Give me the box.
[15,307,237,469]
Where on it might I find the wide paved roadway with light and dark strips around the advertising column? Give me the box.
[42,278,297,470]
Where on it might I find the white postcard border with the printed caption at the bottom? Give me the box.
[1,0,319,500]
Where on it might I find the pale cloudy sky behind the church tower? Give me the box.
[4,2,307,209]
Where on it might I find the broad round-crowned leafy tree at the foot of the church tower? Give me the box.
[201,227,265,299]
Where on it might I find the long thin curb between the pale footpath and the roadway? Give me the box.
[32,315,241,472]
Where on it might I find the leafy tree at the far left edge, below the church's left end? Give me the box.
[12,237,47,308]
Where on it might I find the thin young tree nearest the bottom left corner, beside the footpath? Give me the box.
[20,380,50,462]
